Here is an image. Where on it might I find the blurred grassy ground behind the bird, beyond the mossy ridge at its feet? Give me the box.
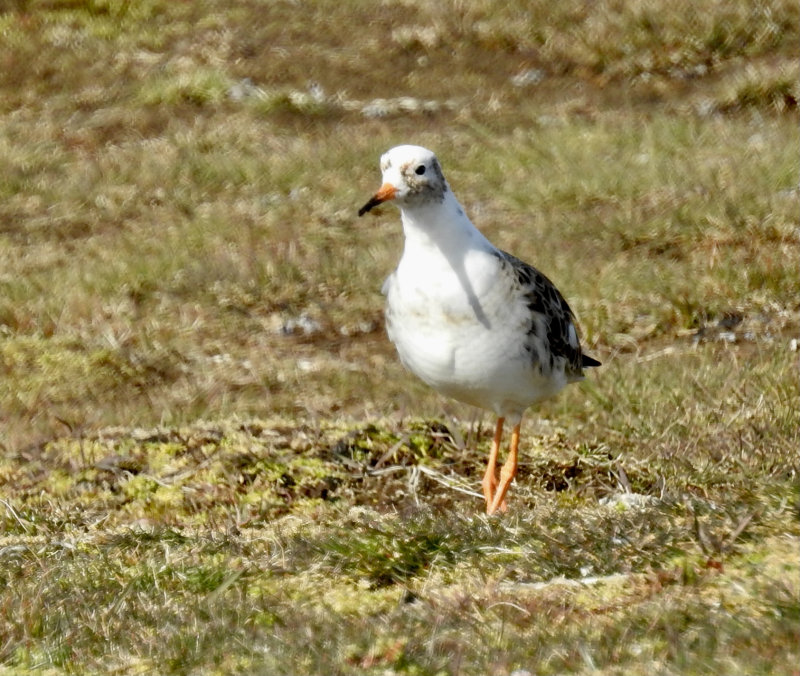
[0,0,800,447]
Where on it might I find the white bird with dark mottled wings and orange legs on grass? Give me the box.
[358,145,600,515]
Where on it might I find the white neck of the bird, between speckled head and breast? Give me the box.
[401,190,494,259]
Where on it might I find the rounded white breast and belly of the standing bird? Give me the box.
[384,246,566,417]
